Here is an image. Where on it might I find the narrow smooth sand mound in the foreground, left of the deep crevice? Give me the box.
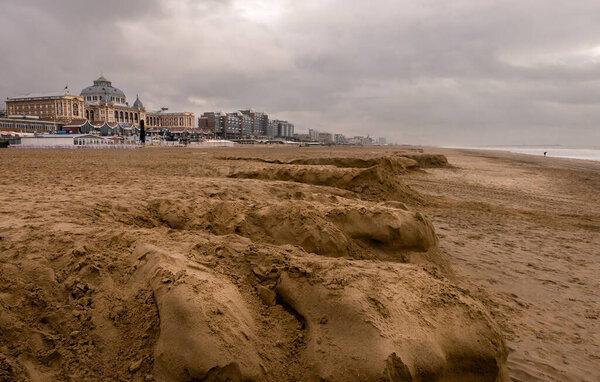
[133,245,261,382]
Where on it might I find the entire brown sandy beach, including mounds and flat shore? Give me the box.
[0,147,600,381]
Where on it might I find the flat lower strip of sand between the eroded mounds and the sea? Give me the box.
[407,149,600,381]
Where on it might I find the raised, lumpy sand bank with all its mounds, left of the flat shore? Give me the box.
[0,149,507,382]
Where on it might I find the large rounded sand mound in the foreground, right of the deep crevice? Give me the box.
[276,259,507,381]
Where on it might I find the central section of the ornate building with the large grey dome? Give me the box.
[81,75,146,126]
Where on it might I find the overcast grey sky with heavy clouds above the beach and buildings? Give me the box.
[0,0,600,146]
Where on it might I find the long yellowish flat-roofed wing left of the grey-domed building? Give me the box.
[6,89,86,123]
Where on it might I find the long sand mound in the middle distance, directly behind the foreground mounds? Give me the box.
[132,197,451,274]
